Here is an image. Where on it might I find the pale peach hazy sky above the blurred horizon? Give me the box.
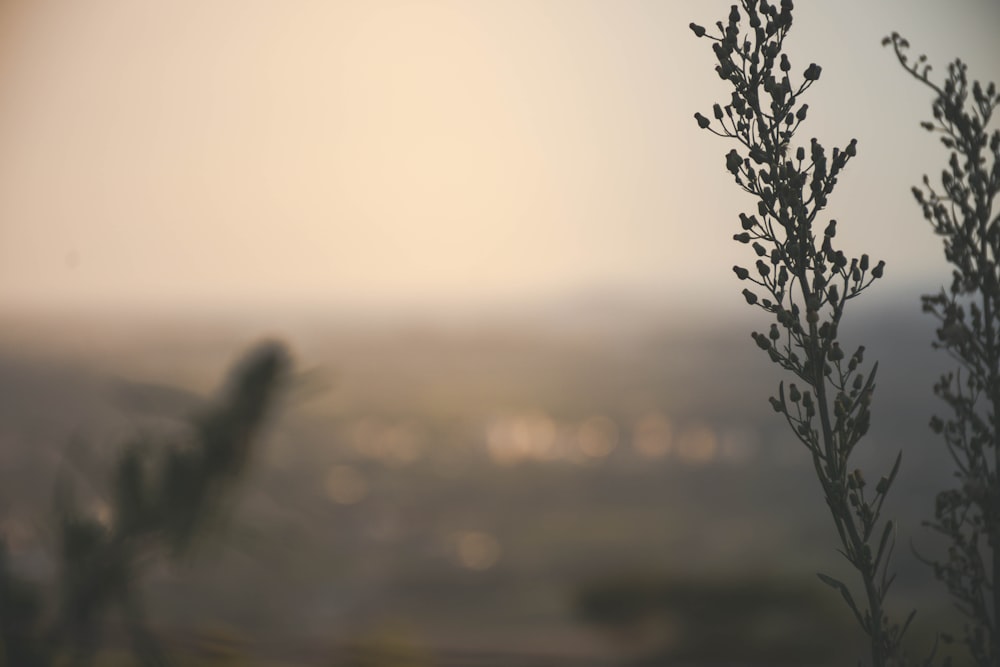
[0,0,1000,318]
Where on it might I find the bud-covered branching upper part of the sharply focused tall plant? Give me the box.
[691,0,885,430]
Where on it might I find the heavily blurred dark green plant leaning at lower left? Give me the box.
[0,343,289,667]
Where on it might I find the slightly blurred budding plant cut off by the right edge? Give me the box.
[882,33,1000,665]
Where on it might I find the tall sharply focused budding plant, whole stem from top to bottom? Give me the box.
[691,0,913,667]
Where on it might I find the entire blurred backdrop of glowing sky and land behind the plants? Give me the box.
[0,0,1000,667]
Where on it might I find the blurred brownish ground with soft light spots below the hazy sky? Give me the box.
[0,300,968,665]
